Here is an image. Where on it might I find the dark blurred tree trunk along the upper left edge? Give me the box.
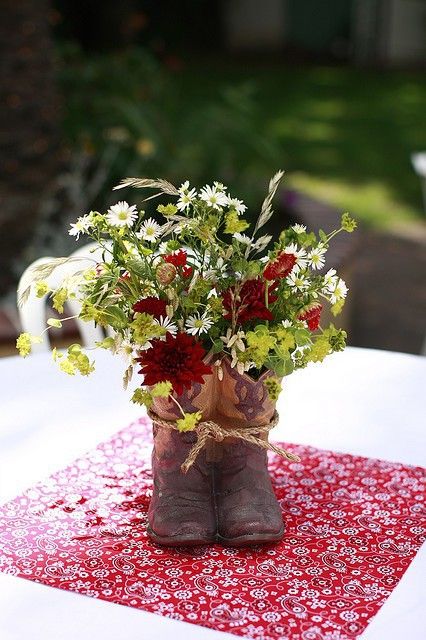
[0,0,60,294]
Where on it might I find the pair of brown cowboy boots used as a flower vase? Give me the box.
[148,360,284,546]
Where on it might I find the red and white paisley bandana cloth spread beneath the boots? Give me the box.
[0,419,425,640]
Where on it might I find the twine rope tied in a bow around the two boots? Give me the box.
[148,409,300,473]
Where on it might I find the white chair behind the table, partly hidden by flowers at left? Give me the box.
[18,242,110,353]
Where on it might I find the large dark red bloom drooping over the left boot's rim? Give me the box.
[137,332,212,395]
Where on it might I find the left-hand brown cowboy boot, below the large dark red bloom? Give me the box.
[148,375,216,546]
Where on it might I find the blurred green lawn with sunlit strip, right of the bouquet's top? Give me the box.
[178,62,426,228]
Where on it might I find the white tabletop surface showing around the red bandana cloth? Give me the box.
[0,348,426,640]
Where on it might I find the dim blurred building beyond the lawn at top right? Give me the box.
[223,0,426,67]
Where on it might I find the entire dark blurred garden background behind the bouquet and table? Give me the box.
[0,0,426,352]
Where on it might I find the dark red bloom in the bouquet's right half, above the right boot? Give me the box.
[222,278,278,323]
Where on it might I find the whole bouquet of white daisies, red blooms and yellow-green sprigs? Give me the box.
[17,171,356,431]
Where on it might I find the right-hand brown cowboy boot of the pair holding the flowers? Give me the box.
[214,359,284,546]
